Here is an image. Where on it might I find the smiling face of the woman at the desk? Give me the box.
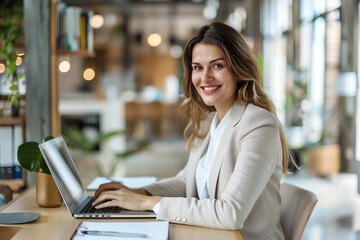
[191,43,237,119]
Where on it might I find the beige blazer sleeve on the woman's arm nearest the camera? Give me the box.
[157,108,282,230]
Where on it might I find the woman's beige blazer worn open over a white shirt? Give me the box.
[145,103,284,240]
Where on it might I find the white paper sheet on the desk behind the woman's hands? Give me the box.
[87,177,156,190]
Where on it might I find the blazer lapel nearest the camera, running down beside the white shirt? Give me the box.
[209,103,246,199]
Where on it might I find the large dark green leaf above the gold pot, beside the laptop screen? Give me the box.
[18,142,51,175]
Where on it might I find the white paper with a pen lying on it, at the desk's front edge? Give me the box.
[71,221,169,240]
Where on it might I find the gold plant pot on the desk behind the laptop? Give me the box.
[36,173,62,207]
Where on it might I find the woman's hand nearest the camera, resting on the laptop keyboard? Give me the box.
[93,188,162,211]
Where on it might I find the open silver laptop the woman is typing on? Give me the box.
[39,136,156,218]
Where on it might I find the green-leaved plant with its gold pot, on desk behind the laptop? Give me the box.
[17,136,62,207]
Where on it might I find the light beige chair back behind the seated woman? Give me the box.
[280,183,318,240]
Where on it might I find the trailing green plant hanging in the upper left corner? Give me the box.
[0,0,24,117]
